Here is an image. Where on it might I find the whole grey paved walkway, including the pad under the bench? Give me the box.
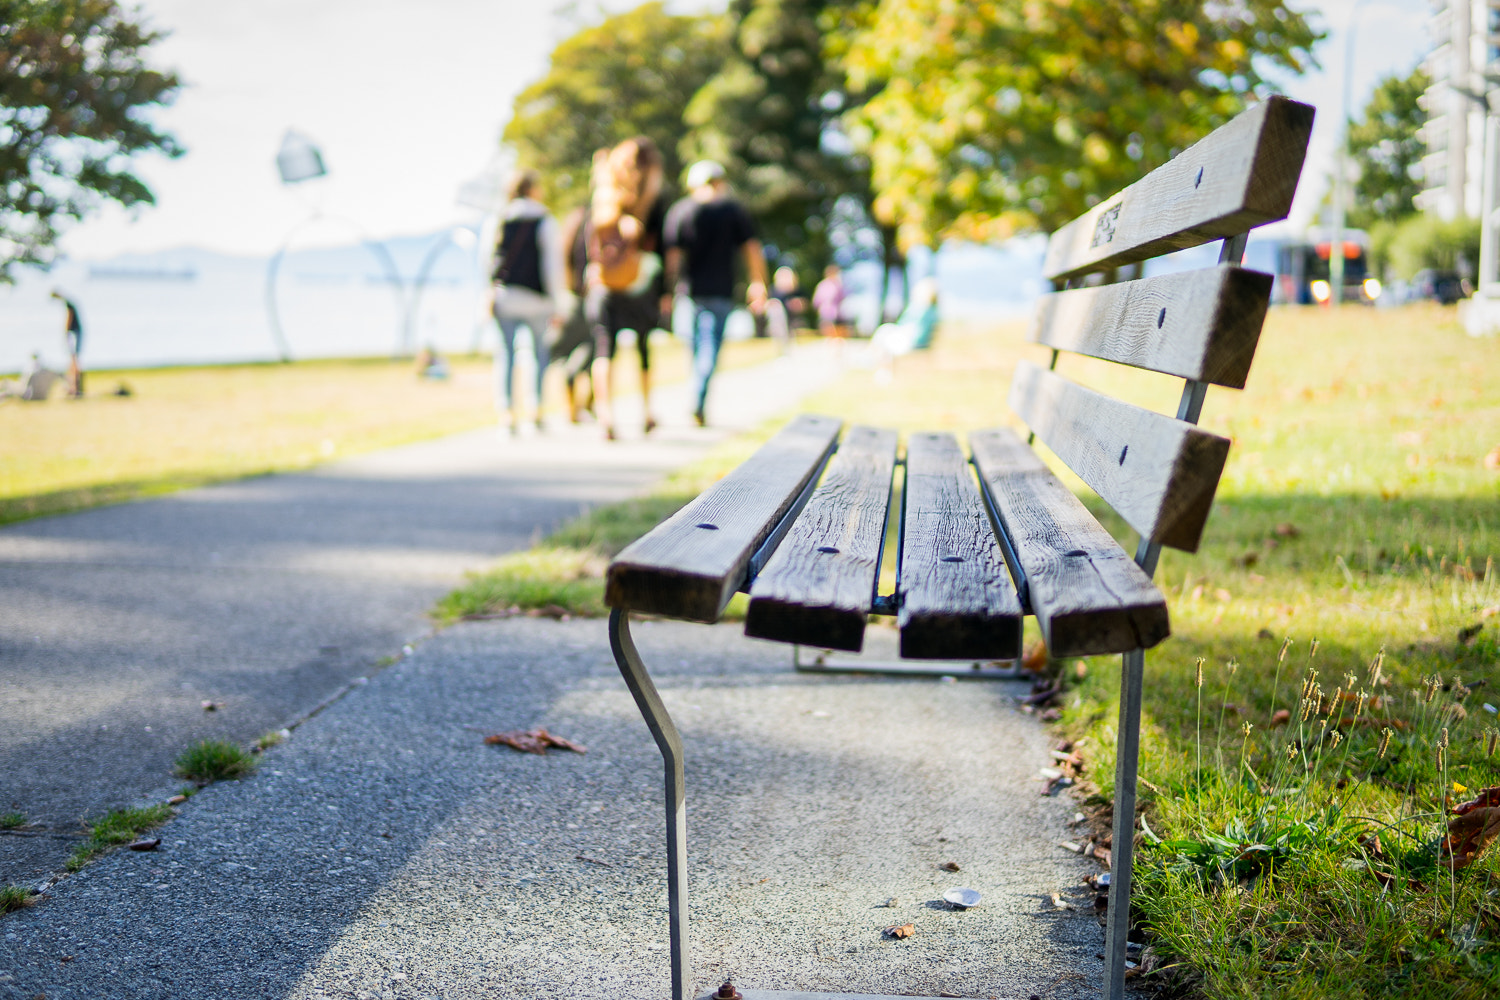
[0,344,1103,1000]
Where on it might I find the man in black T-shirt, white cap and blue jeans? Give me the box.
[662,160,765,427]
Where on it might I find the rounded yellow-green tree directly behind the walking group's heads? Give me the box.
[503,3,731,210]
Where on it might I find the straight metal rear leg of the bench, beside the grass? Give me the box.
[1104,649,1146,1000]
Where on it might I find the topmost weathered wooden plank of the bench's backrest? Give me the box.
[1043,97,1314,280]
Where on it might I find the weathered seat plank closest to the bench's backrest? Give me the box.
[969,429,1172,657]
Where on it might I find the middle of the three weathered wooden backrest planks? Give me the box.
[1028,264,1274,388]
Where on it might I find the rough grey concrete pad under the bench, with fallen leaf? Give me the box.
[0,618,1103,1000]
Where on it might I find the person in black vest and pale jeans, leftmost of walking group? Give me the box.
[494,169,569,435]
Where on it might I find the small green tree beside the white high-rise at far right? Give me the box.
[1347,69,1431,229]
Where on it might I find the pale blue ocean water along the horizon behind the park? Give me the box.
[0,234,1046,372]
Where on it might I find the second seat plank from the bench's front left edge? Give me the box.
[746,427,896,652]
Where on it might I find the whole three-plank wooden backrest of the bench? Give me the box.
[1010,97,1314,554]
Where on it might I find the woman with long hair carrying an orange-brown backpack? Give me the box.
[585,135,666,441]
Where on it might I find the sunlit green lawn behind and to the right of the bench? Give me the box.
[438,306,1500,999]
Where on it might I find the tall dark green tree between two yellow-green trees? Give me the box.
[683,0,878,282]
